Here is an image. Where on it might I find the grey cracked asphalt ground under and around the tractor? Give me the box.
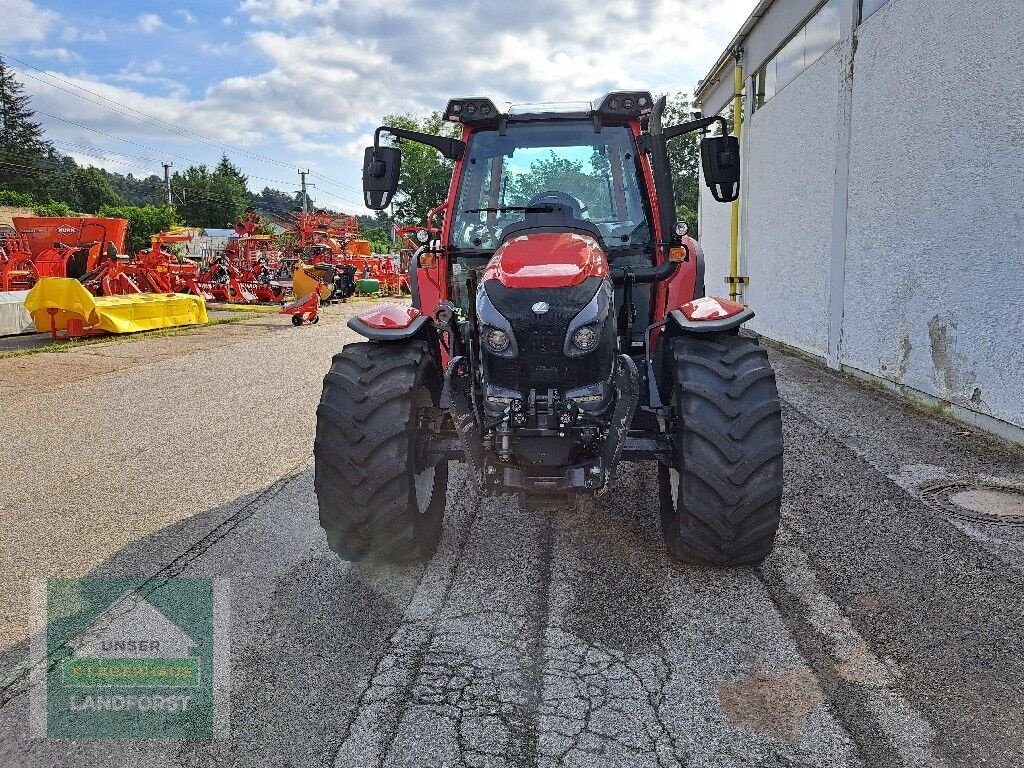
[0,305,1024,768]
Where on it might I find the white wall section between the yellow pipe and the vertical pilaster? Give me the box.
[740,46,840,356]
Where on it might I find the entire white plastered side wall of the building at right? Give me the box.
[700,0,1024,439]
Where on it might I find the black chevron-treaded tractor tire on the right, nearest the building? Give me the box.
[658,334,782,565]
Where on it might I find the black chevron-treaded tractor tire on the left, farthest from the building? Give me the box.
[313,341,447,562]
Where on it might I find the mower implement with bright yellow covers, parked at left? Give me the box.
[25,278,207,336]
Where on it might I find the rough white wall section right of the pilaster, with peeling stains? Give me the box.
[839,0,1024,434]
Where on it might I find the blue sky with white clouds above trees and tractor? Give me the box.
[0,0,756,213]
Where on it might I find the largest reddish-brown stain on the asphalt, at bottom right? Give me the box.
[718,669,823,743]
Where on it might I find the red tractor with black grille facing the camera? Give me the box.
[314,91,782,565]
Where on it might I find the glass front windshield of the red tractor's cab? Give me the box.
[451,121,652,250]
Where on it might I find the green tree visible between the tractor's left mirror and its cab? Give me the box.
[383,112,455,224]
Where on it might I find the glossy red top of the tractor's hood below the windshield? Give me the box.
[483,231,608,289]
